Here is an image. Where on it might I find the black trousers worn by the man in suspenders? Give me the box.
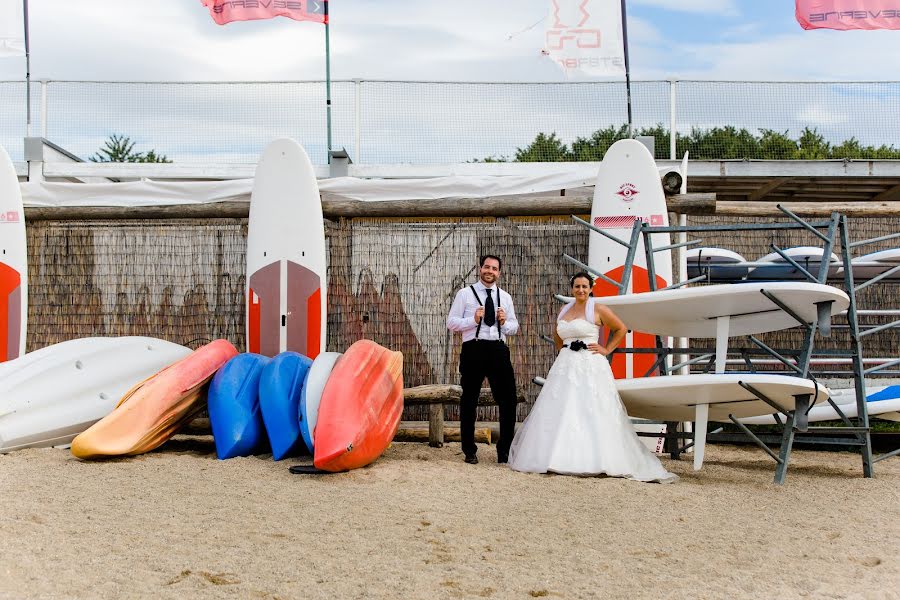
[459,340,516,459]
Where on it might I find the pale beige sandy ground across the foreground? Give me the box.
[0,437,900,599]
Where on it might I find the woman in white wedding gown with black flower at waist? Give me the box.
[509,273,678,483]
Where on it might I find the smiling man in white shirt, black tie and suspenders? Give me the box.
[447,254,519,465]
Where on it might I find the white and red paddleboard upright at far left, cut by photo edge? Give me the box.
[0,146,28,363]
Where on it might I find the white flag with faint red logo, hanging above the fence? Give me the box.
[544,0,625,77]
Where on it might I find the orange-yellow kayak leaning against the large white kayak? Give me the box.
[72,340,238,459]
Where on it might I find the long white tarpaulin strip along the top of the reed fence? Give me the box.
[21,168,597,206]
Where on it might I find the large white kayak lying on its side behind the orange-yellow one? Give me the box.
[0,337,191,453]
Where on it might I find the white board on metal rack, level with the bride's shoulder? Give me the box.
[603,281,850,338]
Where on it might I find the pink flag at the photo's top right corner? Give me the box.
[797,0,900,31]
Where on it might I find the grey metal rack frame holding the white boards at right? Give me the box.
[564,205,900,484]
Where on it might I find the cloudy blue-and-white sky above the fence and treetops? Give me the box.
[0,0,900,163]
